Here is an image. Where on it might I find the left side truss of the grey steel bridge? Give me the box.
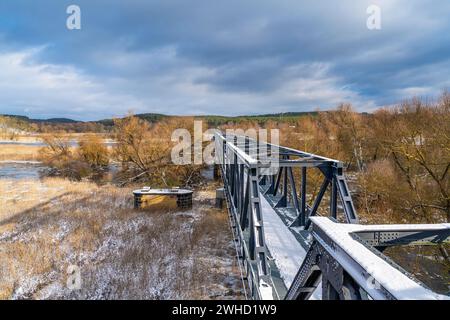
[215,134,276,299]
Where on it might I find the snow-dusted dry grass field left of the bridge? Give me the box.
[0,179,240,299]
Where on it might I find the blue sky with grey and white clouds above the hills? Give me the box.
[0,0,450,120]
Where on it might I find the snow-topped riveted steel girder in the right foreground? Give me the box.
[285,217,450,300]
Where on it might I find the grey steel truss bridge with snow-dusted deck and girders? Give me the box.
[214,131,450,300]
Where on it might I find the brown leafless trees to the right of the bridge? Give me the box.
[255,92,450,223]
